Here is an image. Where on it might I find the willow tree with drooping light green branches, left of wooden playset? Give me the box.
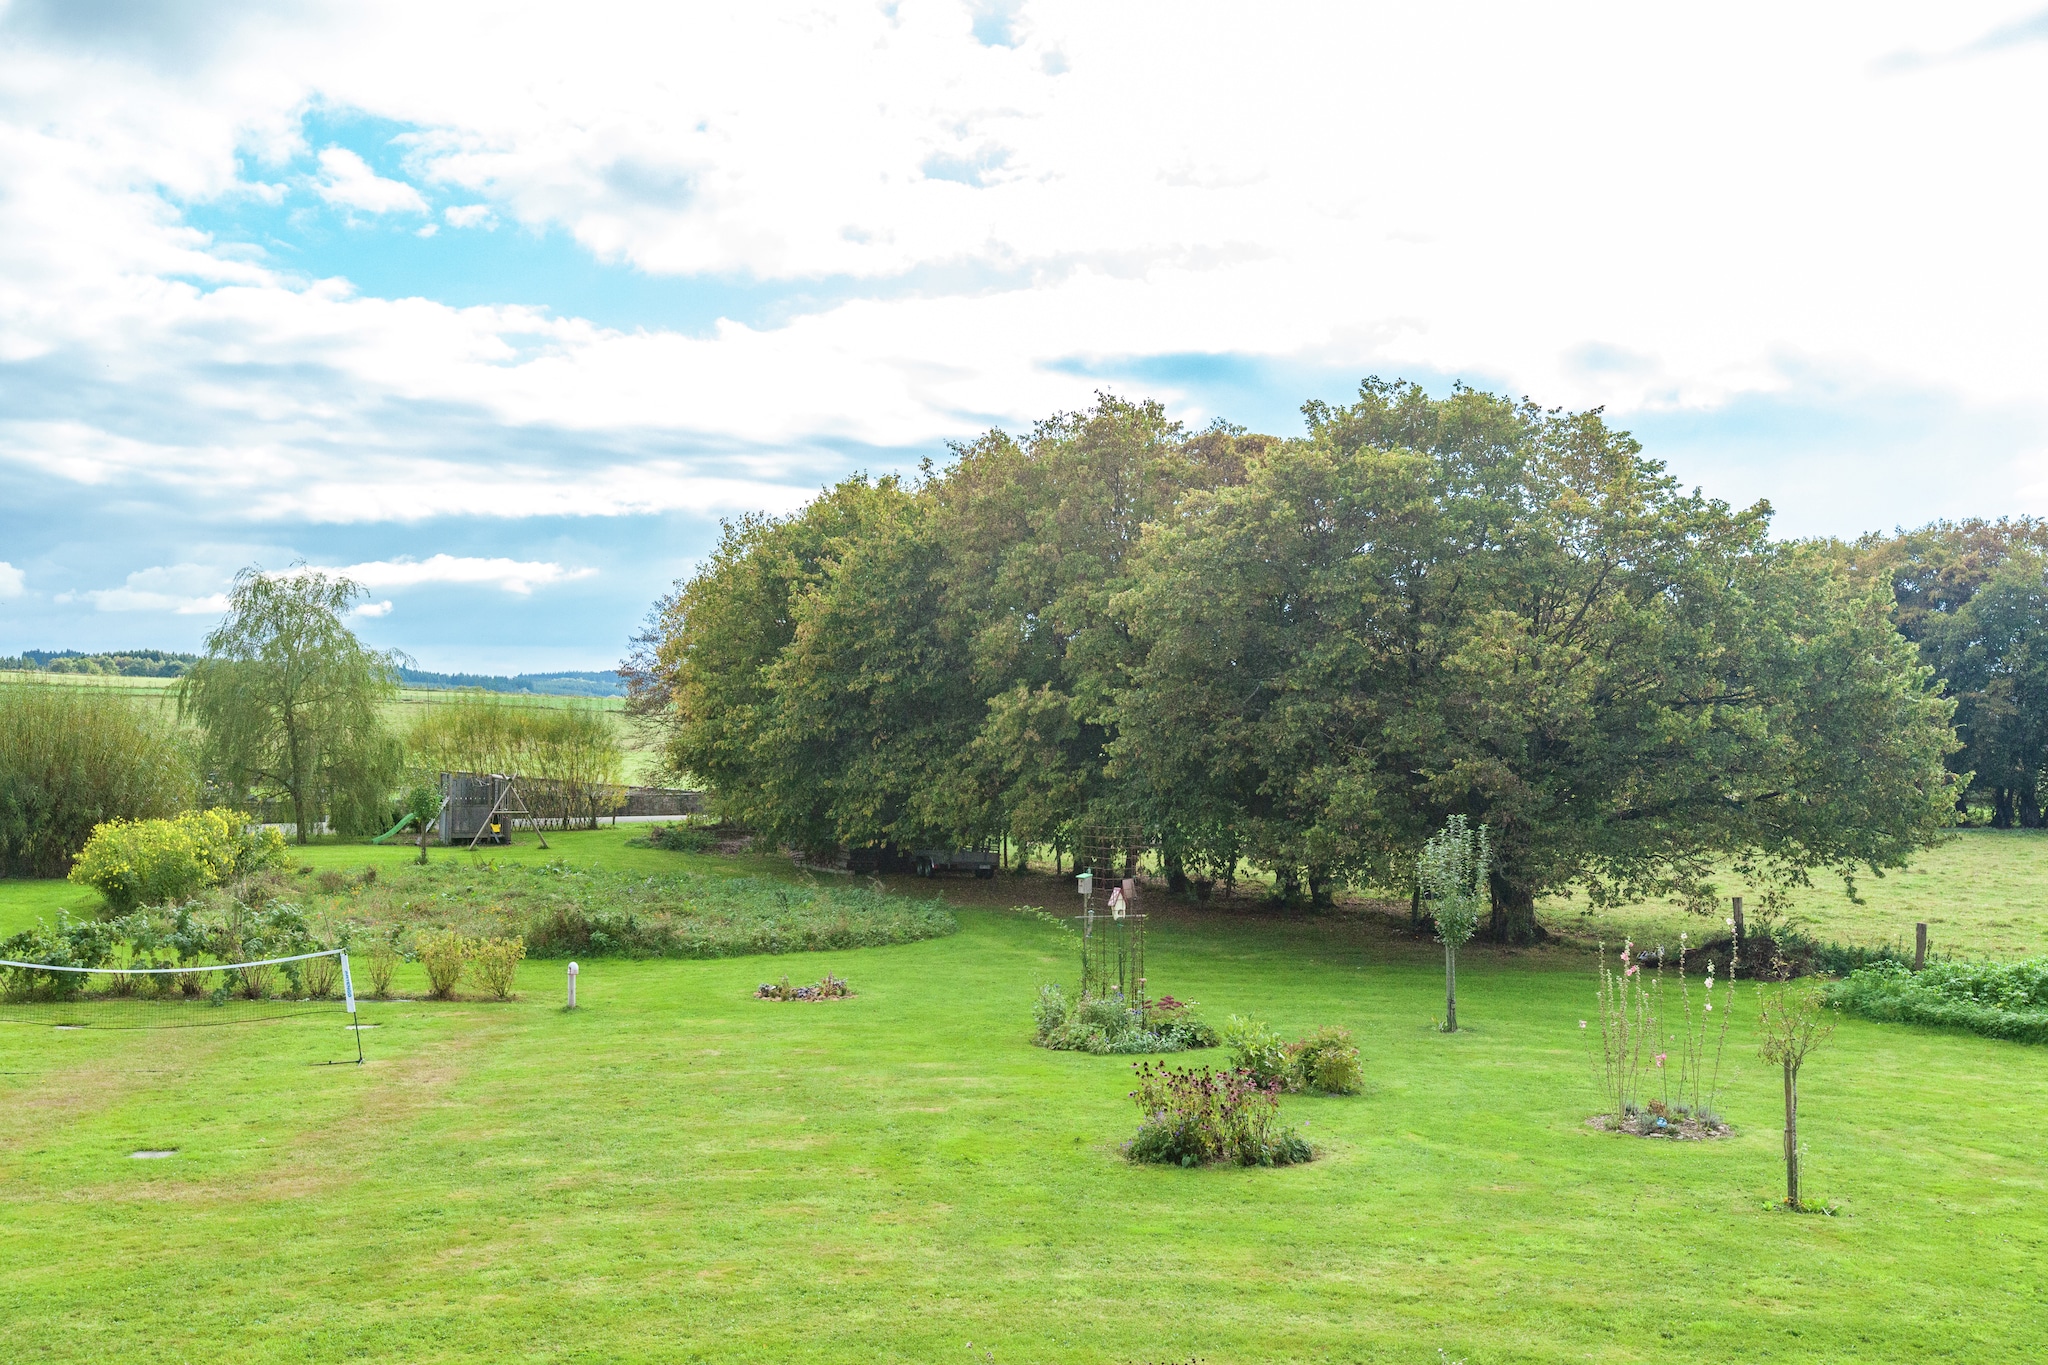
[178,567,399,843]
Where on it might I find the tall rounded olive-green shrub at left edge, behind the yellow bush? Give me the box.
[0,684,197,876]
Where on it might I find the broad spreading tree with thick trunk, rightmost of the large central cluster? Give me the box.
[1116,381,1954,941]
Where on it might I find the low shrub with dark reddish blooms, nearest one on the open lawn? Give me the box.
[1124,1062,1315,1166]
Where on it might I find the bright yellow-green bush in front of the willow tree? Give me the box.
[72,806,285,915]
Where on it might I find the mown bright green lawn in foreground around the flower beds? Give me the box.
[0,833,2048,1365]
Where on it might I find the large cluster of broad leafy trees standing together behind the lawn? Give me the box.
[627,381,1954,941]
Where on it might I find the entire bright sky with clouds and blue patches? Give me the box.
[0,0,2048,671]
